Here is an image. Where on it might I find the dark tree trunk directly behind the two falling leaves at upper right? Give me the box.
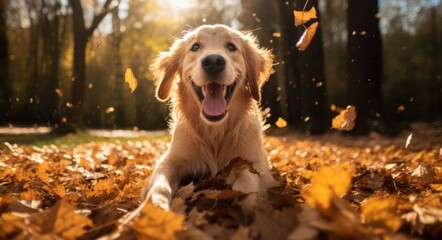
[295,0,330,134]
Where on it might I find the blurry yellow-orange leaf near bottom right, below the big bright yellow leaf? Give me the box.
[361,197,402,231]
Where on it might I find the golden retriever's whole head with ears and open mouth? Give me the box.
[151,25,273,124]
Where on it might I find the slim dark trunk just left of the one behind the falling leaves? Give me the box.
[278,0,301,129]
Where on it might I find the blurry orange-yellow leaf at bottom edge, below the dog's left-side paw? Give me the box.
[131,202,184,239]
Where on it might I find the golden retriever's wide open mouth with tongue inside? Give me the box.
[191,81,236,122]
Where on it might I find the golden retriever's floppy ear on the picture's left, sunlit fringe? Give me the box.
[150,39,184,101]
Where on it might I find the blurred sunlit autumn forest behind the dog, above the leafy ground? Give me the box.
[0,0,442,134]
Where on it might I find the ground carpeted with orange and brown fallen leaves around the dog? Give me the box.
[0,124,442,239]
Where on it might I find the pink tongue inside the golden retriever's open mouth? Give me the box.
[203,83,227,117]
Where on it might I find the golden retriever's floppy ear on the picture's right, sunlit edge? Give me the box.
[244,33,273,101]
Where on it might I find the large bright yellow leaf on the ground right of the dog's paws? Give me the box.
[301,167,351,210]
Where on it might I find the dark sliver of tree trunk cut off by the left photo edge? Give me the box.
[0,1,11,121]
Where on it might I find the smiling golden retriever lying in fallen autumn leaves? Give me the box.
[143,25,275,210]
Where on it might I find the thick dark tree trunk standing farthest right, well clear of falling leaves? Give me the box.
[347,0,383,134]
